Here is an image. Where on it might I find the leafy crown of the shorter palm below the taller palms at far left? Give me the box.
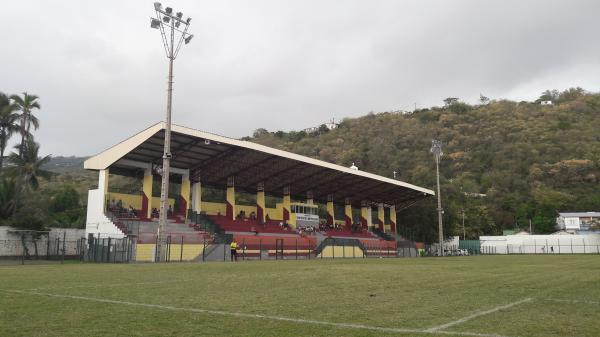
[8,137,52,190]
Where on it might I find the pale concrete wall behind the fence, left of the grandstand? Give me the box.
[0,226,85,257]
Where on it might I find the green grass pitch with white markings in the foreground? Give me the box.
[0,255,600,337]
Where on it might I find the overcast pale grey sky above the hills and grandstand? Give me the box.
[0,0,600,156]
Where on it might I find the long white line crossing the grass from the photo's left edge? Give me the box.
[0,289,508,337]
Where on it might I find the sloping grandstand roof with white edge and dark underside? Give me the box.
[84,122,434,208]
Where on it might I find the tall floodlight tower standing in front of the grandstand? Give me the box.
[150,2,194,262]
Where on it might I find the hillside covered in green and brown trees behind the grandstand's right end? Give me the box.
[248,88,600,242]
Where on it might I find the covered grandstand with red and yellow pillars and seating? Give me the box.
[84,123,434,261]
